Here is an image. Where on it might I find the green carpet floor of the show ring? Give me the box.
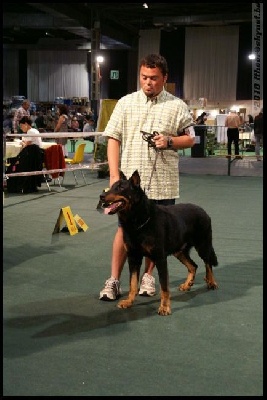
[3,166,263,397]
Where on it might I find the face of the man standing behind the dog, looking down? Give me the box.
[139,66,167,98]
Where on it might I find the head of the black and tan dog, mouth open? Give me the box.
[97,171,143,215]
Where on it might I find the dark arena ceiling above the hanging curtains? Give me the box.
[3,2,252,49]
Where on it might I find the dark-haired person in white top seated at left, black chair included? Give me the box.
[6,117,44,193]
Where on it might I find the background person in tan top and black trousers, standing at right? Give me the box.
[225,110,242,158]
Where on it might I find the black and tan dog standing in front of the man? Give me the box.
[98,171,218,315]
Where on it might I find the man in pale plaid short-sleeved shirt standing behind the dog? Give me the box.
[99,54,194,300]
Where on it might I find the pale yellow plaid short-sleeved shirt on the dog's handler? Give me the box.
[104,89,193,200]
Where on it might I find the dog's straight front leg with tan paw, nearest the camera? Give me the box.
[156,259,171,315]
